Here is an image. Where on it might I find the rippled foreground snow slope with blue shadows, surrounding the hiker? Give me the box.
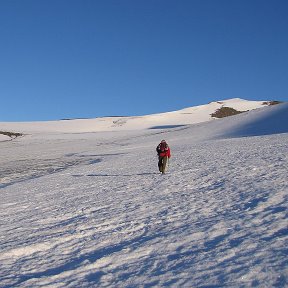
[0,100,288,287]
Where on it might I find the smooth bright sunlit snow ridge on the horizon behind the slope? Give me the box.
[0,98,276,133]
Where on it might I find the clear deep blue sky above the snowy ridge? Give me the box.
[0,0,288,121]
